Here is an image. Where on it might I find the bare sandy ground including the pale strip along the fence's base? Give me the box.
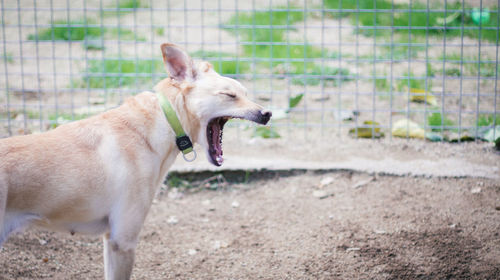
[0,135,500,279]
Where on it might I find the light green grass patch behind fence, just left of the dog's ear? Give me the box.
[80,59,163,88]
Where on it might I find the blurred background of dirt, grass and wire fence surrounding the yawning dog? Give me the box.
[0,0,500,279]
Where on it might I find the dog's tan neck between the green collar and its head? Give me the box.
[155,78,200,144]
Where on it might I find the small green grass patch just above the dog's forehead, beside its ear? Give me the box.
[191,51,250,75]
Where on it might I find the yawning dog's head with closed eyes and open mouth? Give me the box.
[157,43,272,166]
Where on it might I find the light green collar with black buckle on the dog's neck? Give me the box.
[156,92,196,161]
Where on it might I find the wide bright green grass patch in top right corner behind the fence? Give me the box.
[324,0,498,42]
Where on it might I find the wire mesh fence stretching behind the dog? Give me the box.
[0,0,500,142]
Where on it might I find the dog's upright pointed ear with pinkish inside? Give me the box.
[161,43,197,82]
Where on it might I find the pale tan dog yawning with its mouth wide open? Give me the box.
[0,43,272,279]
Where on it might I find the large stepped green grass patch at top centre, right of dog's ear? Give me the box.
[223,7,349,85]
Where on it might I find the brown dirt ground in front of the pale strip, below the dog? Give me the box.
[0,167,500,279]
